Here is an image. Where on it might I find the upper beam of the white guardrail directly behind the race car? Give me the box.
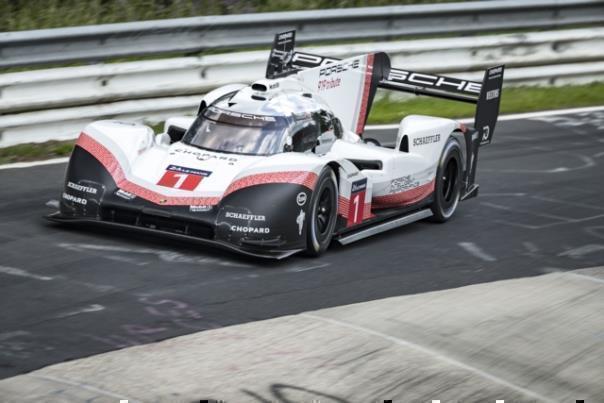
[0,28,604,114]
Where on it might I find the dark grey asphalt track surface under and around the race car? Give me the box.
[0,111,604,378]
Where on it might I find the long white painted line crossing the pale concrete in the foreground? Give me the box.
[300,313,554,402]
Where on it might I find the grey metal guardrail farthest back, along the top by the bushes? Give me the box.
[0,0,604,67]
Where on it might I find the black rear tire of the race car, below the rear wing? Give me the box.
[430,138,462,223]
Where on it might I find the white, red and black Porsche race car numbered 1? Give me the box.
[48,31,504,258]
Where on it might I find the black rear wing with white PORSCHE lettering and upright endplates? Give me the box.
[266,31,504,145]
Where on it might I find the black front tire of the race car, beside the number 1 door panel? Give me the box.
[306,167,338,256]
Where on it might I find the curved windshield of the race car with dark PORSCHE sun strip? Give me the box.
[182,106,289,155]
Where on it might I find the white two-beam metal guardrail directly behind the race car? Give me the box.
[0,28,604,147]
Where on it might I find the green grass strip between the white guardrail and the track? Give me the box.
[0,83,604,164]
